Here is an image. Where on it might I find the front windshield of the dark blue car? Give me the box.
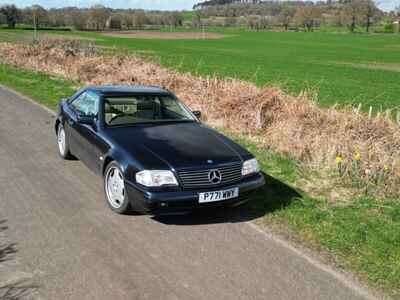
[104,95,195,126]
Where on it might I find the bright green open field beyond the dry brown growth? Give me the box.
[0,29,400,110]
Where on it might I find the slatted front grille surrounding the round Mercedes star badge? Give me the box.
[178,163,242,189]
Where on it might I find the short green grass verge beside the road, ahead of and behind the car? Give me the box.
[0,65,400,299]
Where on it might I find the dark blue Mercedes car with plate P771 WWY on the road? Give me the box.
[55,86,265,214]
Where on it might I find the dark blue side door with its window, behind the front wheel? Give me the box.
[67,91,100,172]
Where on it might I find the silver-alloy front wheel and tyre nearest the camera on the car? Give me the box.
[104,161,130,214]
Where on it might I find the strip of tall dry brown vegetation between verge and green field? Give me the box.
[0,41,400,195]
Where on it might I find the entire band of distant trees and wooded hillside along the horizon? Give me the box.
[0,0,400,32]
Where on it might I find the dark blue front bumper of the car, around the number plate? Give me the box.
[125,173,265,215]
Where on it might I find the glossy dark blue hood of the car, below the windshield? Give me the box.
[104,123,249,169]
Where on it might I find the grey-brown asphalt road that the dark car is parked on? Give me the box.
[0,88,376,300]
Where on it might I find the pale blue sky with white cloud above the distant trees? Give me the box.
[0,0,400,11]
